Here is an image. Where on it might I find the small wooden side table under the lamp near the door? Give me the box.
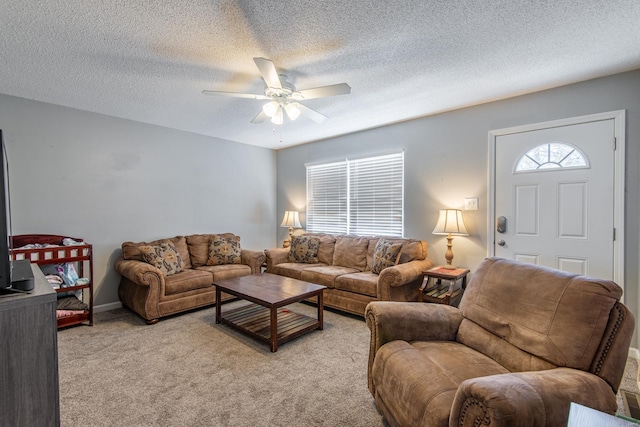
[420,266,469,307]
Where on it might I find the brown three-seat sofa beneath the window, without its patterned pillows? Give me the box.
[265,233,433,316]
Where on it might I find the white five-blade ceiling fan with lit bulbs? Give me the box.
[202,58,351,125]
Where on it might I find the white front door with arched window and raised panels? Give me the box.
[490,112,617,280]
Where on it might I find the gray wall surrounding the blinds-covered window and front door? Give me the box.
[277,71,640,344]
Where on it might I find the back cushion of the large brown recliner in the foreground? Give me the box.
[458,258,622,371]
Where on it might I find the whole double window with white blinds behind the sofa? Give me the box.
[306,153,404,237]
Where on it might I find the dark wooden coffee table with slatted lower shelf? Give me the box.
[214,273,325,352]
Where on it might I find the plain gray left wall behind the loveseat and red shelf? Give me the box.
[0,95,277,305]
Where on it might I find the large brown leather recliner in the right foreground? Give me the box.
[365,258,634,427]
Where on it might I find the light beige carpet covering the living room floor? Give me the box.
[58,302,638,427]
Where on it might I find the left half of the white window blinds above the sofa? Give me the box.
[307,162,347,234]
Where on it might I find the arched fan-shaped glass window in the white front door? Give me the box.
[515,142,589,173]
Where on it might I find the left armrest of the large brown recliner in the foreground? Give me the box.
[364,301,462,396]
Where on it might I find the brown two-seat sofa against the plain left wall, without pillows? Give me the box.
[115,233,265,324]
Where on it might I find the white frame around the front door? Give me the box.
[487,110,626,290]
